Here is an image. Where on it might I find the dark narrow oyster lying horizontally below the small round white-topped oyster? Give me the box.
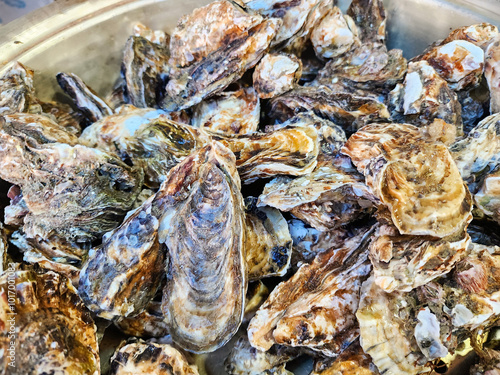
[269,85,389,133]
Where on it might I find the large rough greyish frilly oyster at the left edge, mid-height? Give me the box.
[0,115,142,242]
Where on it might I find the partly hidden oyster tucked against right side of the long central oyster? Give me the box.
[245,197,292,281]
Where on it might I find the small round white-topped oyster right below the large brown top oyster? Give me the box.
[253,53,302,99]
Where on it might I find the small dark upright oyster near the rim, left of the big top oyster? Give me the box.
[122,36,170,108]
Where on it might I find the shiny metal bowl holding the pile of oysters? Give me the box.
[0,0,500,375]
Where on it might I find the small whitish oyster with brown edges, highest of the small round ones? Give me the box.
[311,7,361,59]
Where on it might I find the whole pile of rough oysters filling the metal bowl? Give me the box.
[0,0,500,375]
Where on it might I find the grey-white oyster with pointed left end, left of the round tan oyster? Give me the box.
[259,163,377,231]
